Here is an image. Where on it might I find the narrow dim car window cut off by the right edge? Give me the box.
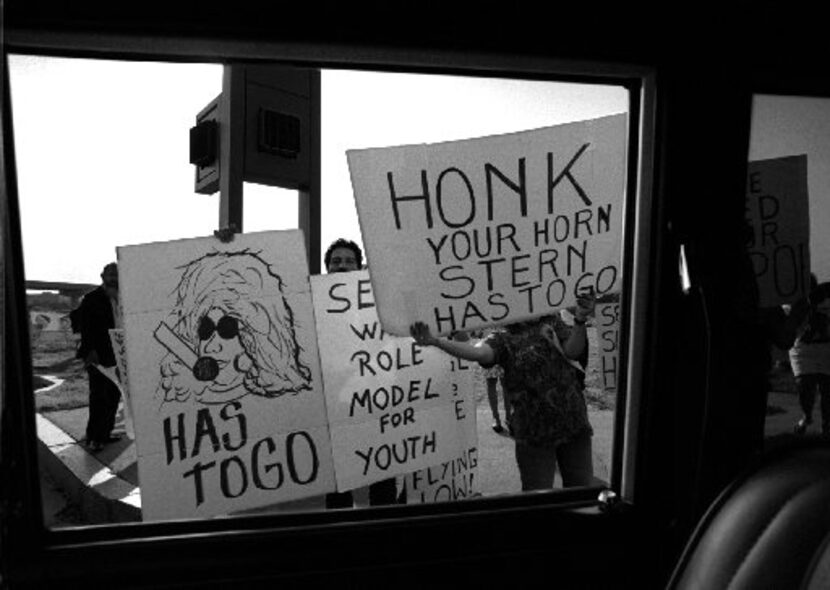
[747,95,830,445]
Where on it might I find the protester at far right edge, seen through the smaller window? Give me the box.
[790,283,830,436]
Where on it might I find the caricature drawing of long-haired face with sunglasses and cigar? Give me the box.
[153,250,312,404]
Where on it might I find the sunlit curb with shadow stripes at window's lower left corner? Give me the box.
[36,414,141,524]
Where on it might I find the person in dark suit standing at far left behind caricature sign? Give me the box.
[71,262,121,451]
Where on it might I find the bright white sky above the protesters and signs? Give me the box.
[9,55,628,283]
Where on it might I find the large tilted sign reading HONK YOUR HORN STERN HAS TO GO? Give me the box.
[347,114,627,336]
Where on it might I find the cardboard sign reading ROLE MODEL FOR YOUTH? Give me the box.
[311,270,476,490]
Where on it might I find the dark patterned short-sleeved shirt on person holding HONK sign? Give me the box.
[485,315,593,447]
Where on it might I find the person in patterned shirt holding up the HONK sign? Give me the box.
[410,293,595,491]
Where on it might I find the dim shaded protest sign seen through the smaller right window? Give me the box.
[746,155,810,307]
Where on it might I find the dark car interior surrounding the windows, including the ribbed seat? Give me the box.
[0,0,830,589]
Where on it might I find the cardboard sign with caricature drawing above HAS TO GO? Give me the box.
[118,230,334,520]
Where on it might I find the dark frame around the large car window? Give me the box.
[0,23,657,588]
